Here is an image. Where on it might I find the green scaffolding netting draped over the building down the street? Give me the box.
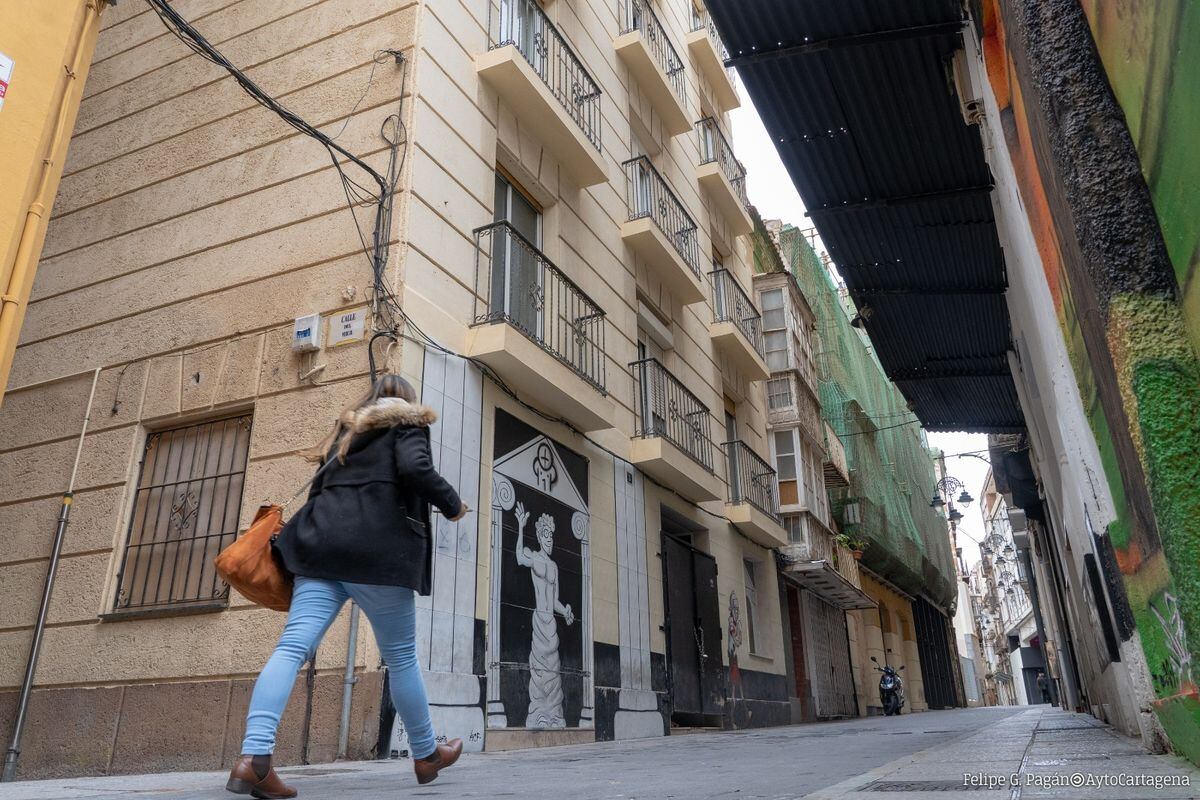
[755,220,955,608]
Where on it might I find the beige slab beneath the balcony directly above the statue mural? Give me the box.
[467,323,617,432]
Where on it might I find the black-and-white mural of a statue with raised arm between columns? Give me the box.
[487,410,594,729]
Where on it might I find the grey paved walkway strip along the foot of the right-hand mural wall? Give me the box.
[804,706,1200,800]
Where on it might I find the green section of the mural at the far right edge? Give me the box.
[1082,0,1200,760]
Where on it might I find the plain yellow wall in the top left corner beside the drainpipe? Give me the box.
[0,0,95,399]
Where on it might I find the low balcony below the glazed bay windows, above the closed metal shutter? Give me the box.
[779,513,875,609]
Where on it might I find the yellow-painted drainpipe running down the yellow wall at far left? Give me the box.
[0,0,101,402]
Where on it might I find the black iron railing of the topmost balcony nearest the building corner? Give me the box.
[487,0,601,150]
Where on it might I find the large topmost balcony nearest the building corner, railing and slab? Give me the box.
[475,0,608,186]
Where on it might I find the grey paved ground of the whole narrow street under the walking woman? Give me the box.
[0,706,1200,800]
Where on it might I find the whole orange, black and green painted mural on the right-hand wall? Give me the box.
[983,0,1200,763]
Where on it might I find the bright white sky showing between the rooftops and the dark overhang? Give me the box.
[731,87,988,567]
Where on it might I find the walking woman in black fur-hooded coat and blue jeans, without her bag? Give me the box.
[226,374,467,799]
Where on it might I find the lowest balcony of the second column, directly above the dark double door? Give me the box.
[629,359,724,503]
